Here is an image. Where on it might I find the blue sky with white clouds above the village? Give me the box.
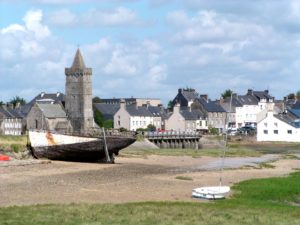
[0,0,300,104]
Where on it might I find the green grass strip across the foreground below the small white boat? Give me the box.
[0,172,300,225]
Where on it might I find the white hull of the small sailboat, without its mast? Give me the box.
[192,186,230,199]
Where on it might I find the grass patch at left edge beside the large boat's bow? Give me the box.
[0,135,27,152]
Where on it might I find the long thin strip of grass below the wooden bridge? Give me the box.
[120,148,262,158]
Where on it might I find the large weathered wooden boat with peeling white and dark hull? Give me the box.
[29,131,136,161]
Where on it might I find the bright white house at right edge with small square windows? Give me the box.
[257,111,300,142]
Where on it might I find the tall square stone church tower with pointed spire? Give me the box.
[65,49,94,134]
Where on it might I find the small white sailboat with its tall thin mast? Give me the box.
[192,94,232,200]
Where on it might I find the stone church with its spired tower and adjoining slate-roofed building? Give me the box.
[27,49,96,134]
